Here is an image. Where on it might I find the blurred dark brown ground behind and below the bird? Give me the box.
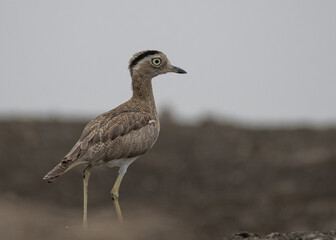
[0,116,336,240]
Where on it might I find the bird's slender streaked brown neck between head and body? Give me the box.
[132,76,157,116]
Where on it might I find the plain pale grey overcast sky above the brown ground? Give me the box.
[0,0,336,124]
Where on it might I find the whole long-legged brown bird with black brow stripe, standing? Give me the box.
[43,50,187,229]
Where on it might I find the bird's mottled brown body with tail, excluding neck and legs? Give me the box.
[44,98,160,180]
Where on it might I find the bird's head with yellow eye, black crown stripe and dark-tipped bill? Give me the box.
[129,50,187,79]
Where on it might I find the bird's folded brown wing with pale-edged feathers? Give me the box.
[62,111,153,164]
